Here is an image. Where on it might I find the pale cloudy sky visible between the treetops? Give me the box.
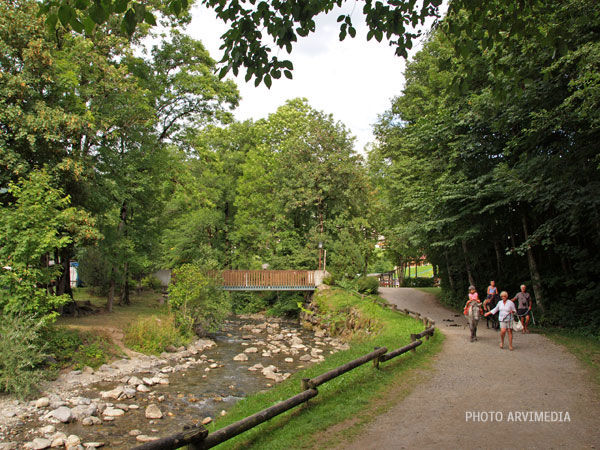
[186,3,428,153]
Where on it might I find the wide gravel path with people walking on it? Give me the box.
[340,288,600,450]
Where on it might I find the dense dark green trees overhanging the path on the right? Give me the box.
[370,0,600,329]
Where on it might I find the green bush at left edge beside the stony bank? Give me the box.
[0,314,47,398]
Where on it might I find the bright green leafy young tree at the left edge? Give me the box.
[0,170,97,316]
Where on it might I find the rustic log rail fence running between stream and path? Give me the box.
[134,305,435,450]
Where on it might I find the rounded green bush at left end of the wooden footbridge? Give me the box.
[169,264,231,335]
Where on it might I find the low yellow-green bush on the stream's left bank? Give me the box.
[125,315,191,355]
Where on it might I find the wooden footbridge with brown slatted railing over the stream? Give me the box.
[213,270,324,291]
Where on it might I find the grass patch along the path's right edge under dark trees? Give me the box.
[537,328,600,388]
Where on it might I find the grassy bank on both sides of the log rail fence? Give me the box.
[204,289,443,449]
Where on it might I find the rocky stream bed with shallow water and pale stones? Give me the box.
[0,315,347,450]
